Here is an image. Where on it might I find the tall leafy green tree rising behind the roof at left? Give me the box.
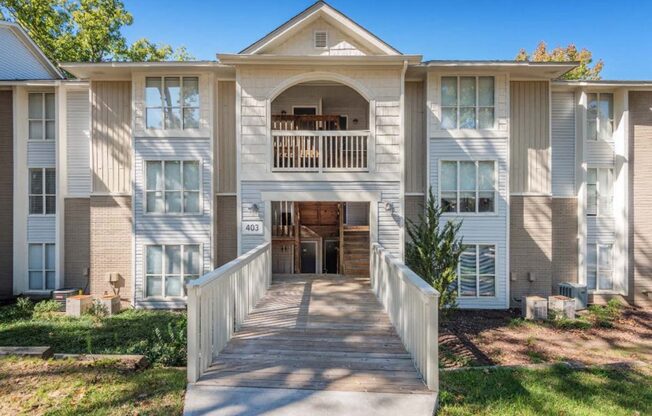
[0,0,192,62]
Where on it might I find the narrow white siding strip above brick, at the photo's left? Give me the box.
[66,91,91,196]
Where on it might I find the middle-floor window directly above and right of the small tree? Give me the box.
[439,161,496,213]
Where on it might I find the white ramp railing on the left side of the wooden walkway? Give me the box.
[187,243,272,383]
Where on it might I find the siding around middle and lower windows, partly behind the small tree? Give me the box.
[429,139,509,308]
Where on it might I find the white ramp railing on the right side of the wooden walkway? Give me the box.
[370,243,439,391]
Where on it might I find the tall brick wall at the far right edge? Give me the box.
[628,92,652,307]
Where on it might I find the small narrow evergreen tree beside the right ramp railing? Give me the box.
[406,189,463,311]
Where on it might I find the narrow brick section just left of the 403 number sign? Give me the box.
[215,196,238,267]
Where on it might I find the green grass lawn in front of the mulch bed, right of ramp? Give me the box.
[438,366,652,416]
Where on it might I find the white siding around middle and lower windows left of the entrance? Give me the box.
[134,138,212,308]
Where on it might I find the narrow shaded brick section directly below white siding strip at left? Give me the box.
[63,198,91,290]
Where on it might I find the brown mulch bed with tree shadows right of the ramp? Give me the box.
[439,309,652,368]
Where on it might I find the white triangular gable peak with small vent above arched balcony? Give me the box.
[240,1,401,56]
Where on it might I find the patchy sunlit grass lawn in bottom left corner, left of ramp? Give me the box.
[0,358,186,415]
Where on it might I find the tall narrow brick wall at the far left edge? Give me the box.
[0,91,14,298]
